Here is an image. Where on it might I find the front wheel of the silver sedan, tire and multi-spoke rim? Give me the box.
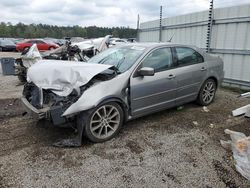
[85,102,124,142]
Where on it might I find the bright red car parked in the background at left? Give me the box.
[16,39,59,52]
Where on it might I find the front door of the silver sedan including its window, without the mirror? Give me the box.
[130,47,176,117]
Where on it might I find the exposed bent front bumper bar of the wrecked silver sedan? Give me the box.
[21,97,49,120]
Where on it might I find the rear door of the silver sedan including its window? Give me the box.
[173,46,207,105]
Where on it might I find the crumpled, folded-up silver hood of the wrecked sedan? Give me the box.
[27,60,112,96]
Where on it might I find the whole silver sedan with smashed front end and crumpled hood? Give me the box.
[22,43,224,144]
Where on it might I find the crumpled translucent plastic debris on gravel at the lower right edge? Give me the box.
[220,129,250,180]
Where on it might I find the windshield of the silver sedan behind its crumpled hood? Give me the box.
[88,46,145,73]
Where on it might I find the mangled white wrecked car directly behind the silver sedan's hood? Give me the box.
[15,35,110,83]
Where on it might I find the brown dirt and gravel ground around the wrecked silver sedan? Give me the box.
[0,52,250,188]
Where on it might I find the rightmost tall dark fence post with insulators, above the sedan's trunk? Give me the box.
[206,0,214,52]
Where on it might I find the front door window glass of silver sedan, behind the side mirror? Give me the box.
[142,48,172,72]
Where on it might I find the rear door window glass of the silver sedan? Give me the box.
[175,47,204,66]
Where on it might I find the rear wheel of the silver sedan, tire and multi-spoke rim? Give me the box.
[196,78,217,106]
